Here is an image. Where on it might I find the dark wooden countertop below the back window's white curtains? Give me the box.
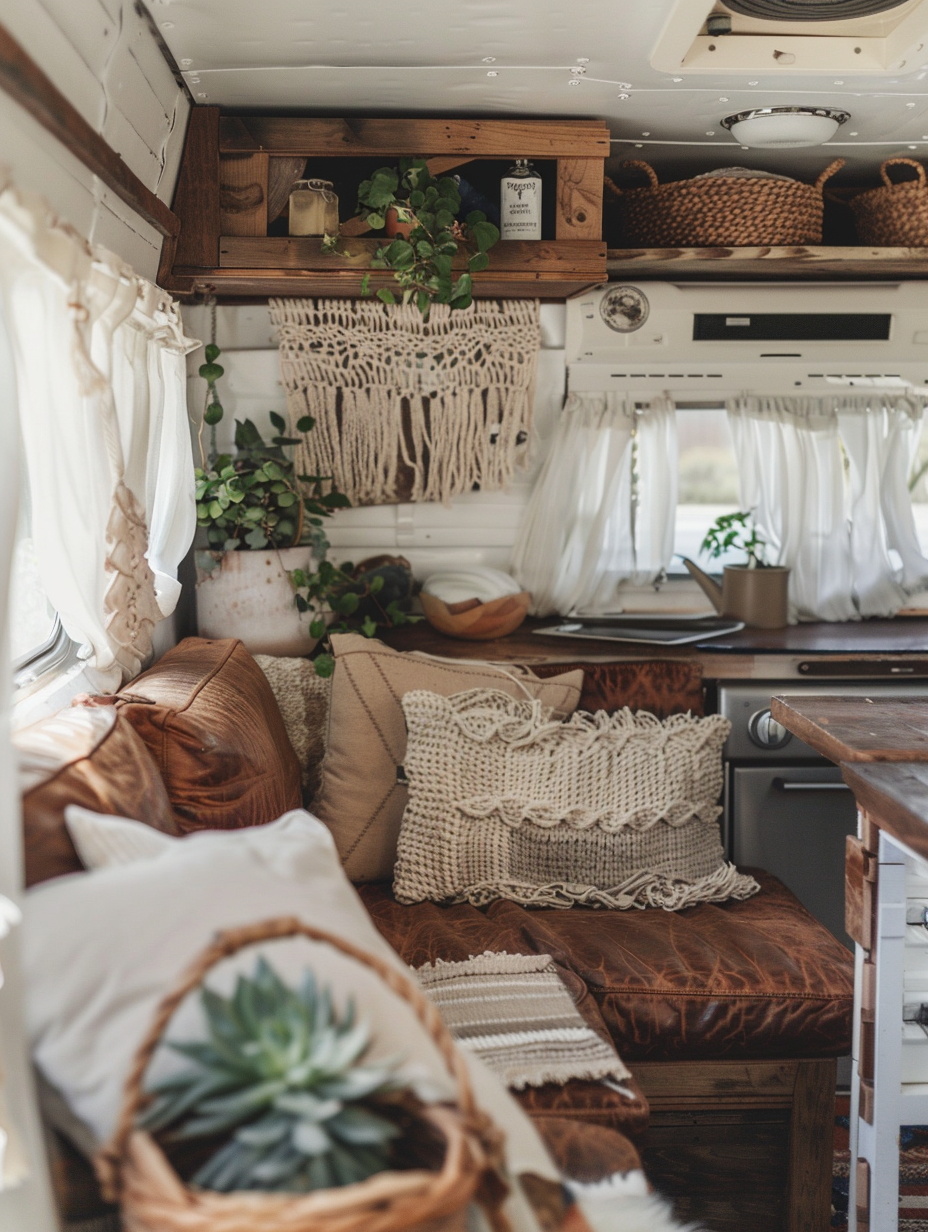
[378,617,928,691]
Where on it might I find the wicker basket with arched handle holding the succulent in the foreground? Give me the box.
[96,918,509,1232]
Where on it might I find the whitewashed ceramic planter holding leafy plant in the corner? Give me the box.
[196,547,318,655]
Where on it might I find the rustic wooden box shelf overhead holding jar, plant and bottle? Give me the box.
[160,107,609,299]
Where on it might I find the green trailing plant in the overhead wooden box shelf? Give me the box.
[357,159,499,319]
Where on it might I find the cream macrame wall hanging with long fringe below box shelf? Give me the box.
[271,299,541,505]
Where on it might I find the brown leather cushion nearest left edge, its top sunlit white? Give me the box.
[14,706,180,886]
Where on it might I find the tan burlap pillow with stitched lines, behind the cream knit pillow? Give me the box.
[313,633,583,882]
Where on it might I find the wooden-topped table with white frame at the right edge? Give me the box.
[770,697,928,1232]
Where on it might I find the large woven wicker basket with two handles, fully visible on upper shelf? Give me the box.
[613,159,844,248]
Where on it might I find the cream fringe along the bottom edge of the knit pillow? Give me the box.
[455,864,760,912]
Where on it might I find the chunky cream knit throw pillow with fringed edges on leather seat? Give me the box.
[393,689,759,910]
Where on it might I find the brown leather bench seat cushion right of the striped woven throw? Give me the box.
[487,870,854,1064]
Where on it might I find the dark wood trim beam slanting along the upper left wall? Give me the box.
[0,25,180,239]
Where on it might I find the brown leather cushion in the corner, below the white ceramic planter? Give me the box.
[113,637,302,833]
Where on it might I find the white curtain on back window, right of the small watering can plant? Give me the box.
[728,394,928,621]
